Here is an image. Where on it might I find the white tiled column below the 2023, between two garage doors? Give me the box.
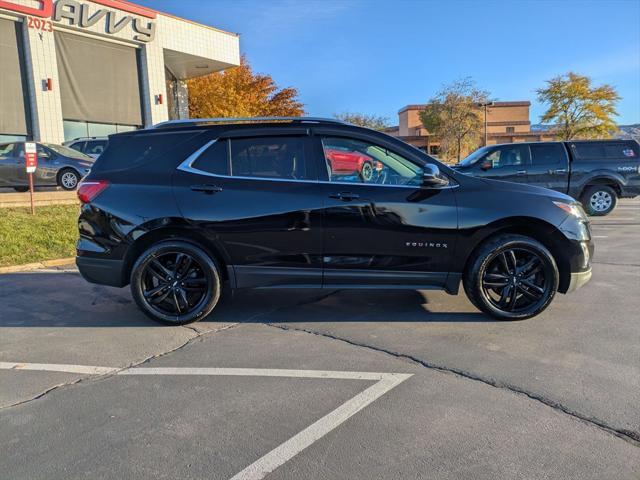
[22,21,64,143]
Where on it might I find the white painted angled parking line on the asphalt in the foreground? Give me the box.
[0,362,412,480]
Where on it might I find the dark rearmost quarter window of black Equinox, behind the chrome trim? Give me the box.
[92,131,201,172]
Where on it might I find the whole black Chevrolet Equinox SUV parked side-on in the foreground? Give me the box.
[77,118,593,324]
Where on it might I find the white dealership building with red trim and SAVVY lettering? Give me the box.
[0,0,240,143]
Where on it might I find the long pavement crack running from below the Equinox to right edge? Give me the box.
[265,322,640,447]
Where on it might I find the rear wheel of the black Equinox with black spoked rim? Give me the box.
[131,240,221,325]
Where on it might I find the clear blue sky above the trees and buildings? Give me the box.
[136,0,640,124]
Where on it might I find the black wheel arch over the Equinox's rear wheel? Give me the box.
[122,225,234,283]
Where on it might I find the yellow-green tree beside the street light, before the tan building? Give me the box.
[420,77,489,162]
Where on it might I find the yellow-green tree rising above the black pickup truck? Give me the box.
[536,72,620,140]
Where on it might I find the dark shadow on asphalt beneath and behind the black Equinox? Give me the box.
[0,270,495,328]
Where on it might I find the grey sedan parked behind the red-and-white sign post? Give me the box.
[0,142,94,192]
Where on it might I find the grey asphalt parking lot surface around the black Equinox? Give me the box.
[0,199,640,479]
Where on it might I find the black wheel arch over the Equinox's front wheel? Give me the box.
[463,217,571,293]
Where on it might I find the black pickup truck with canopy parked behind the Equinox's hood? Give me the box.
[454,140,640,215]
